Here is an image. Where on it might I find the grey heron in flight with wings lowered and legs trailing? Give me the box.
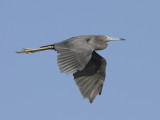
[17,35,125,103]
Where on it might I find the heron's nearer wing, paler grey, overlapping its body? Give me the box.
[54,37,94,74]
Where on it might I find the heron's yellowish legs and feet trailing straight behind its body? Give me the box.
[16,44,55,53]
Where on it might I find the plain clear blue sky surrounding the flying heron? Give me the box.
[0,0,160,120]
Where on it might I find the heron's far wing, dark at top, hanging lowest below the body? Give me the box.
[73,51,107,103]
